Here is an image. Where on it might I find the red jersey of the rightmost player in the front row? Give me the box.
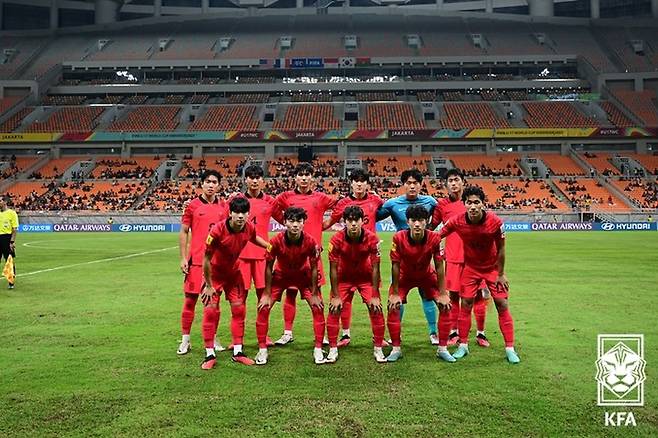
[441,212,505,272]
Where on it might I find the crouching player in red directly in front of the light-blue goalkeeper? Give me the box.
[387,205,455,362]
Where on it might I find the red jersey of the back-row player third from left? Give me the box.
[274,190,336,245]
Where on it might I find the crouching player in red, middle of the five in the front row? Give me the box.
[327,205,386,363]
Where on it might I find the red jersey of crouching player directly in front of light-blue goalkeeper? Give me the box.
[391,230,443,279]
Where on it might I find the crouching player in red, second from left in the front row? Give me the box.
[256,207,325,365]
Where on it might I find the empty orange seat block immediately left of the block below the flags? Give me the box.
[187,105,258,131]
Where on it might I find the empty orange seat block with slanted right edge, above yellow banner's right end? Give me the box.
[523,102,599,128]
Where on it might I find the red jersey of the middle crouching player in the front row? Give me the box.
[329,228,380,279]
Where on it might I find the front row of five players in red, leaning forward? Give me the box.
[184,182,520,369]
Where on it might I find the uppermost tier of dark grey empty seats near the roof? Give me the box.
[0,16,658,79]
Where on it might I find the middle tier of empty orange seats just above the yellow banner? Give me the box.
[0,98,658,133]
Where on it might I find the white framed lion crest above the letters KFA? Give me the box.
[596,335,646,406]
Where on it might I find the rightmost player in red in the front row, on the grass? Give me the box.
[440,186,520,363]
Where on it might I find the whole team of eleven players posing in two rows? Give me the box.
[178,163,519,369]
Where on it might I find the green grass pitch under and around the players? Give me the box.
[0,232,658,437]
